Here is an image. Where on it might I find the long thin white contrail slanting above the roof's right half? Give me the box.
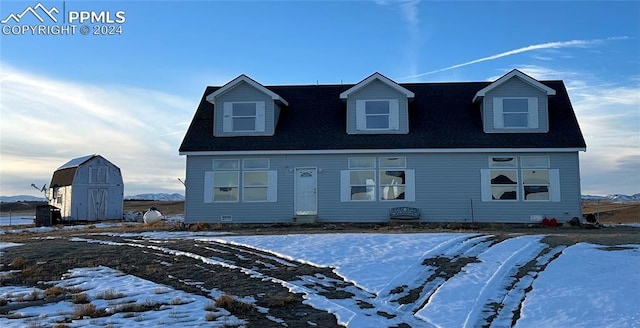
[399,36,628,80]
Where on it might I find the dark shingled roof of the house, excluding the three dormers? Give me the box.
[180,81,586,152]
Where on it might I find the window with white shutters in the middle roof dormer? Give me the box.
[356,99,398,130]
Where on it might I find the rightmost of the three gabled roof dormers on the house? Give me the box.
[473,69,556,133]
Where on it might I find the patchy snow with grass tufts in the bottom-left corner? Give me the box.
[0,267,245,327]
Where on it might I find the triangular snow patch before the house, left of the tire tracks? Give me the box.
[209,233,471,293]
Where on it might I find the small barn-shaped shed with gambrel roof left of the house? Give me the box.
[48,155,124,221]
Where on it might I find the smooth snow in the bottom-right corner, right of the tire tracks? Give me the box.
[516,243,640,327]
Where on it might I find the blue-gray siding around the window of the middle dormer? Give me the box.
[347,80,409,134]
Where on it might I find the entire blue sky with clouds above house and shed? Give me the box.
[0,1,640,195]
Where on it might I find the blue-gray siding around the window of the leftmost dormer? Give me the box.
[213,82,280,137]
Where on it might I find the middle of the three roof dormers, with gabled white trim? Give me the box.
[340,73,414,134]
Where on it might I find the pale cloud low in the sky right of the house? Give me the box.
[516,65,640,194]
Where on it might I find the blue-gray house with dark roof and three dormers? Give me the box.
[179,70,586,223]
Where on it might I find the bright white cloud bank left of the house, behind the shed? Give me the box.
[0,64,197,194]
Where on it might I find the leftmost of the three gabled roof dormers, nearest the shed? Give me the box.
[206,74,289,137]
